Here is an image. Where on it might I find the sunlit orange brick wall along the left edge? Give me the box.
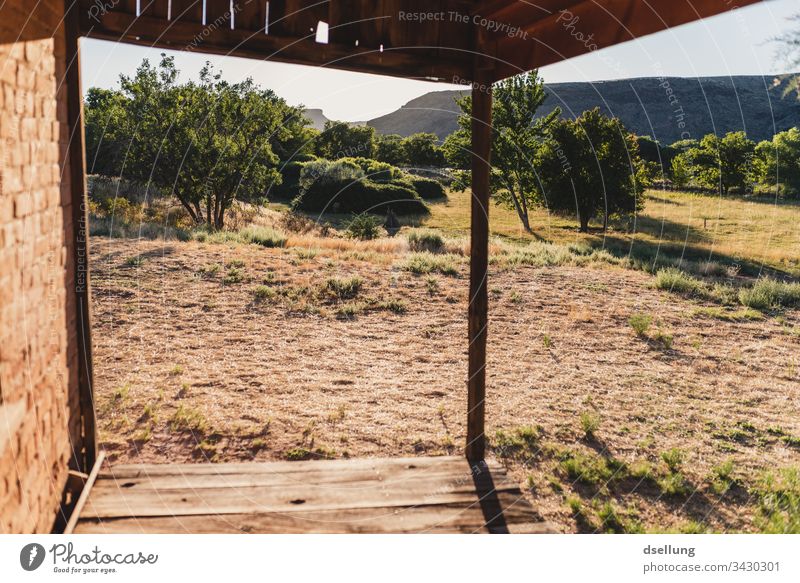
[0,0,80,533]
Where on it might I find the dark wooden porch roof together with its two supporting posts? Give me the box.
[65,0,760,471]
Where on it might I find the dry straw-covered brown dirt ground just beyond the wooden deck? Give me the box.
[91,237,800,532]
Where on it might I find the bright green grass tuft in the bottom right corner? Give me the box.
[751,466,800,534]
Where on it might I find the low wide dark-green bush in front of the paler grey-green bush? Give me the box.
[292,179,429,215]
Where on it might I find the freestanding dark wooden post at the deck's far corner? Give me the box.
[466,67,492,462]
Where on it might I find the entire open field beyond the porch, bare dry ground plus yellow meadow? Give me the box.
[91,193,800,532]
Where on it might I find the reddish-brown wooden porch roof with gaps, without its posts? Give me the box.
[78,0,759,82]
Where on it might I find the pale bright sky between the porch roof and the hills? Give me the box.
[81,0,800,121]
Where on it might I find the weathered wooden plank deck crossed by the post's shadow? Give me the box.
[74,457,551,533]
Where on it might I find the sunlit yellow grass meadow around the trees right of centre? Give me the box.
[424,191,800,277]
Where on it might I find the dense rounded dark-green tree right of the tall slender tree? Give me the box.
[536,108,647,232]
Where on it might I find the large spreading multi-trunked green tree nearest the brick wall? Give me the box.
[87,55,305,229]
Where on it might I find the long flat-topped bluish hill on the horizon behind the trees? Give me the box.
[367,75,800,144]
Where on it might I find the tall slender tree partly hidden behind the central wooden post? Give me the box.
[444,71,561,233]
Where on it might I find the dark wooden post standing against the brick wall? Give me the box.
[62,2,97,473]
